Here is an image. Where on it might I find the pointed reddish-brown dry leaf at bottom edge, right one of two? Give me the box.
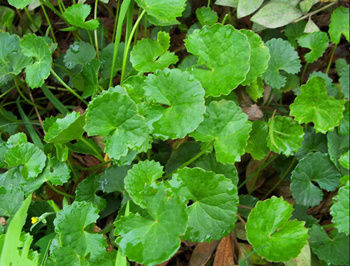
[213,236,235,266]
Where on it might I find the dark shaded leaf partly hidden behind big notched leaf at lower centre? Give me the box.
[194,153,238,186]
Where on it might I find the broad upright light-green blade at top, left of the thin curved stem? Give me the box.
[109,0,131,87]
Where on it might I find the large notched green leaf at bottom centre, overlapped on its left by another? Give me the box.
[170,168,238,242]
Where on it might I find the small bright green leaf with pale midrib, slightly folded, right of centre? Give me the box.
[267,116,304,156]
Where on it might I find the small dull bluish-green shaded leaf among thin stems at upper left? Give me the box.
[63,41,96,69]
